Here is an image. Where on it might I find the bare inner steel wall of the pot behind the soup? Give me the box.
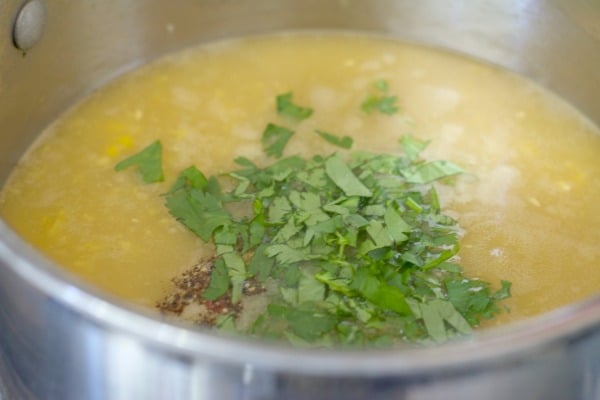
[0,0,600,188]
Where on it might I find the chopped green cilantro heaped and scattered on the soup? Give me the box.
[137,90,510,347]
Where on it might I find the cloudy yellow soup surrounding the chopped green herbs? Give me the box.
[0,34,600,338]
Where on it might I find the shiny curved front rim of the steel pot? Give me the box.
[0,219,600,377]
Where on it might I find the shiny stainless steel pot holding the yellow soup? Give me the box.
[0,0,600,400]
